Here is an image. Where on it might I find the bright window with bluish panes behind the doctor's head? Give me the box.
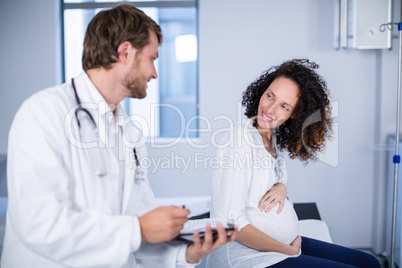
[62,0,198,138]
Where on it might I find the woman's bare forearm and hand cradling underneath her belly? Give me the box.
[236,224,301,255]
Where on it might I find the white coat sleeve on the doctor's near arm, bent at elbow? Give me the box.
[7,97,138,267]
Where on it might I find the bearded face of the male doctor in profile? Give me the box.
[122,32,159,99]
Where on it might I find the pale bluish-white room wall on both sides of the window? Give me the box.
[0,0,399,252]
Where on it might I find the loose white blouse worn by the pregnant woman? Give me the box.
[207,120,298,268]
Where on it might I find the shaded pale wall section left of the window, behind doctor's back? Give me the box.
[0,0,60,153]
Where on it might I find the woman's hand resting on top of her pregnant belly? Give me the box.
[258,182,288,214]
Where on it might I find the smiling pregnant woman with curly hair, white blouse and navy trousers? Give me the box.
[207,60,380,268]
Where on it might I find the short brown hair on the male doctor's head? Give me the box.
[82,3,162,71]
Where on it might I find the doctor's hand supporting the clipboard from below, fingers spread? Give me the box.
[186,223,238,263]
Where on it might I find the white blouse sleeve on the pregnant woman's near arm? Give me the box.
[211,130,252,230]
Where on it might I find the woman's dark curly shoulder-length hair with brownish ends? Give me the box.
[242,59,332,164]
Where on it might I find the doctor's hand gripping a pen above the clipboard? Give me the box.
[138,206,190,243]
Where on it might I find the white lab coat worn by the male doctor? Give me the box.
[1,73,189,268]
